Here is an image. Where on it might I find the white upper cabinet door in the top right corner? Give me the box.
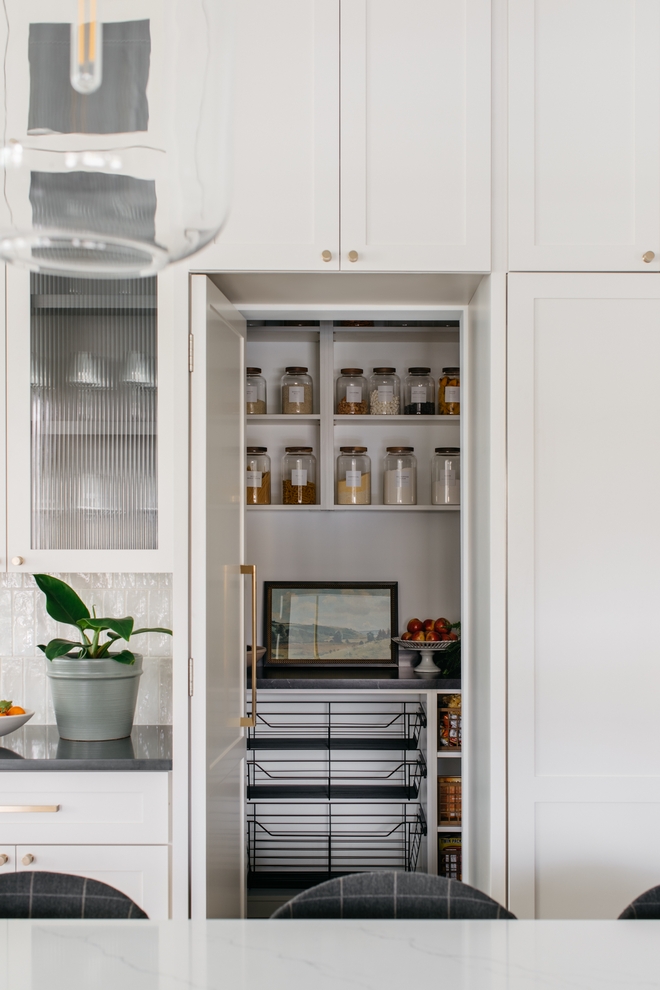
[509,0,660,271]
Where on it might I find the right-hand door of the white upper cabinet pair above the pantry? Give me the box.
[341,0,490,272]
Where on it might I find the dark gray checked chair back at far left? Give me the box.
[0,871,148,919]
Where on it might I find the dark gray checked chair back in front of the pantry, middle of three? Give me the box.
[272,873,515,919]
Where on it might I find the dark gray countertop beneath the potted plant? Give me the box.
[0,724,172,772]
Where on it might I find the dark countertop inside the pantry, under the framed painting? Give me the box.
[247,662,461,691]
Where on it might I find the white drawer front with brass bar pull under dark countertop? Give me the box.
[0,771,169,845]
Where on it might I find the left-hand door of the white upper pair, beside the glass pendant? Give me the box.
[195,0,339,271]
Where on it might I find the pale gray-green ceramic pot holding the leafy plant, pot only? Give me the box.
[45,653,142,740]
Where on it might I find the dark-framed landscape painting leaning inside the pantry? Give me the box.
[264,581,398,667]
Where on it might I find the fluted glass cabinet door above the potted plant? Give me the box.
[7,272,174,571]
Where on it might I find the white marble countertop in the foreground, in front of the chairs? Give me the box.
[0,921,660,990]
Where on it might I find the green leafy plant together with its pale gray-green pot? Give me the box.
[34,574,172,740]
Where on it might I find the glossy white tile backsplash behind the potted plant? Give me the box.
[0,573,172,725]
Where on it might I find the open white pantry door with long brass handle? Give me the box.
[190,275,245,918]
